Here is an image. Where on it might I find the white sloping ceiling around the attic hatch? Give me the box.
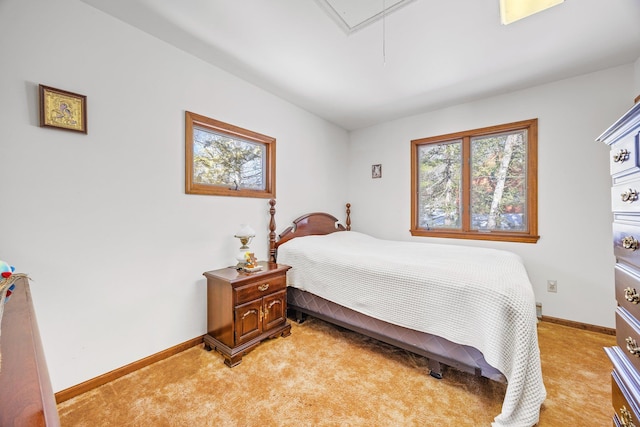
[82,0,640,130]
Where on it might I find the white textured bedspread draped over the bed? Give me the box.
[278,231,546,427]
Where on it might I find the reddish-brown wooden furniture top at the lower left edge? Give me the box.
[0,278,60,427]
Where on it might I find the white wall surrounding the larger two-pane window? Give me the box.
[349,64,635,327]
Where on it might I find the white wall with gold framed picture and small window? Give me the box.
[0,0,348,391]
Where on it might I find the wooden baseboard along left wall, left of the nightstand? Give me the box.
[55,335,204,403]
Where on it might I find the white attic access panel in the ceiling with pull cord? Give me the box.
[316,0,415,34]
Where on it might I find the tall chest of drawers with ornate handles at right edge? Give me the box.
[597,103,640,427]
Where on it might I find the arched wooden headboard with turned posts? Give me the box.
[269,199,351,262]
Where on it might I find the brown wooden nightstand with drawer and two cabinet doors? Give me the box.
[203,262,291,367]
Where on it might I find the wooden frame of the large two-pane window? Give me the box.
[410,119,540,243]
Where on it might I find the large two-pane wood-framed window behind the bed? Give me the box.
[411,119,539,243]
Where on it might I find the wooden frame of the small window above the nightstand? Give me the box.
[185,111,276,199]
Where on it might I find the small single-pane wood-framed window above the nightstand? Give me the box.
[185,111,276,198]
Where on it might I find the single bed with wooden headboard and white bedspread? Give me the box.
[269,200,546,427]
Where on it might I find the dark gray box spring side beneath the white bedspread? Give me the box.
[287,286,506,383]
